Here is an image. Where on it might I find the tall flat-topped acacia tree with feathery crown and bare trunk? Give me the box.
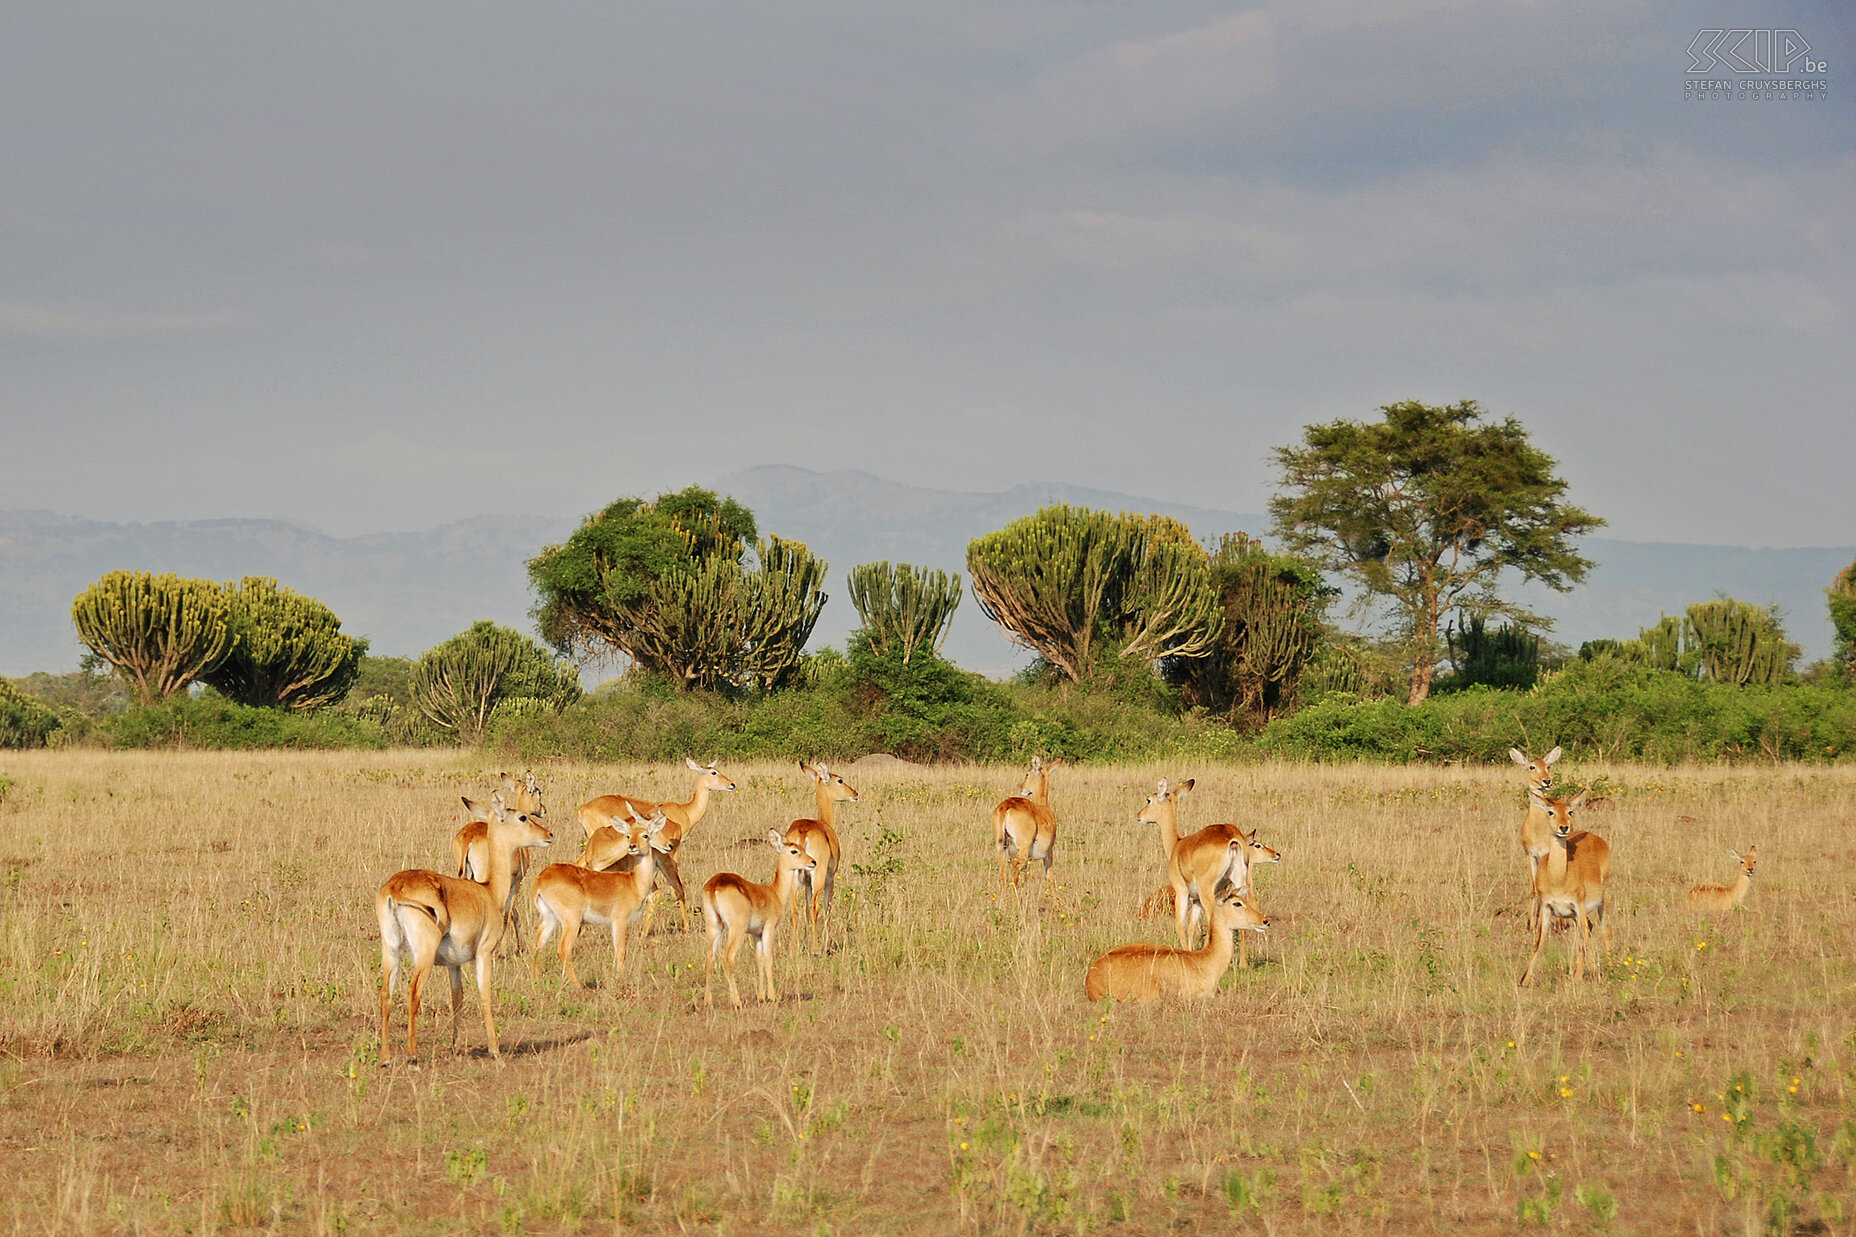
[1270,399,1604,704]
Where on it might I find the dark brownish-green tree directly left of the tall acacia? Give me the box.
[1164,533,1333,723]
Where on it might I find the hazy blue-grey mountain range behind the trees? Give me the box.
[0,466,1856,676]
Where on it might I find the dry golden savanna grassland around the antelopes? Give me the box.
[0,750,1856,1233]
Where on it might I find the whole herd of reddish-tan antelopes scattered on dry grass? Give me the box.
[375,747,1758,1066]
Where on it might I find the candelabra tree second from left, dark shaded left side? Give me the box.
[202,576,367,713]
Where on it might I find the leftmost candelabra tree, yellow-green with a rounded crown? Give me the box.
[71,572,232,704]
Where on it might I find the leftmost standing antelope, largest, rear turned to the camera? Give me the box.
[373,793,553,1066]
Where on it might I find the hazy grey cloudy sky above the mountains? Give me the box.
[0,0,1856,544]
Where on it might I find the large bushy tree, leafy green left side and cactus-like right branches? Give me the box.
[529,487,826,691]
